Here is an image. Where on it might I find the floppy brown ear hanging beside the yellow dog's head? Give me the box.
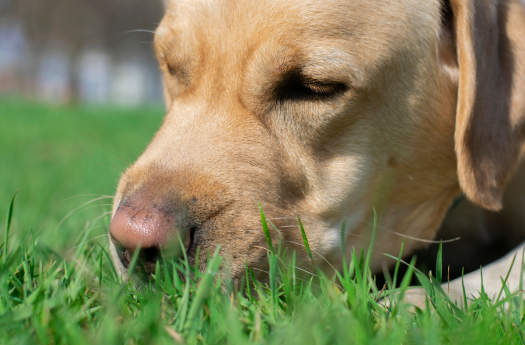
[439,0,525,210]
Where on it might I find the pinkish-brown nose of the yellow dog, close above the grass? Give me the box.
[109,199,191,275]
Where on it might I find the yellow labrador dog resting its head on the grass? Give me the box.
[110,0,525,302]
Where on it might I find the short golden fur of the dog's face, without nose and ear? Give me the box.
[108,0,523,280]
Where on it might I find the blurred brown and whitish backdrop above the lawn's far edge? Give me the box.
[0,0,162,107]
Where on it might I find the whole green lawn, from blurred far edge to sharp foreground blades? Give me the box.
[0,99,525,345]
